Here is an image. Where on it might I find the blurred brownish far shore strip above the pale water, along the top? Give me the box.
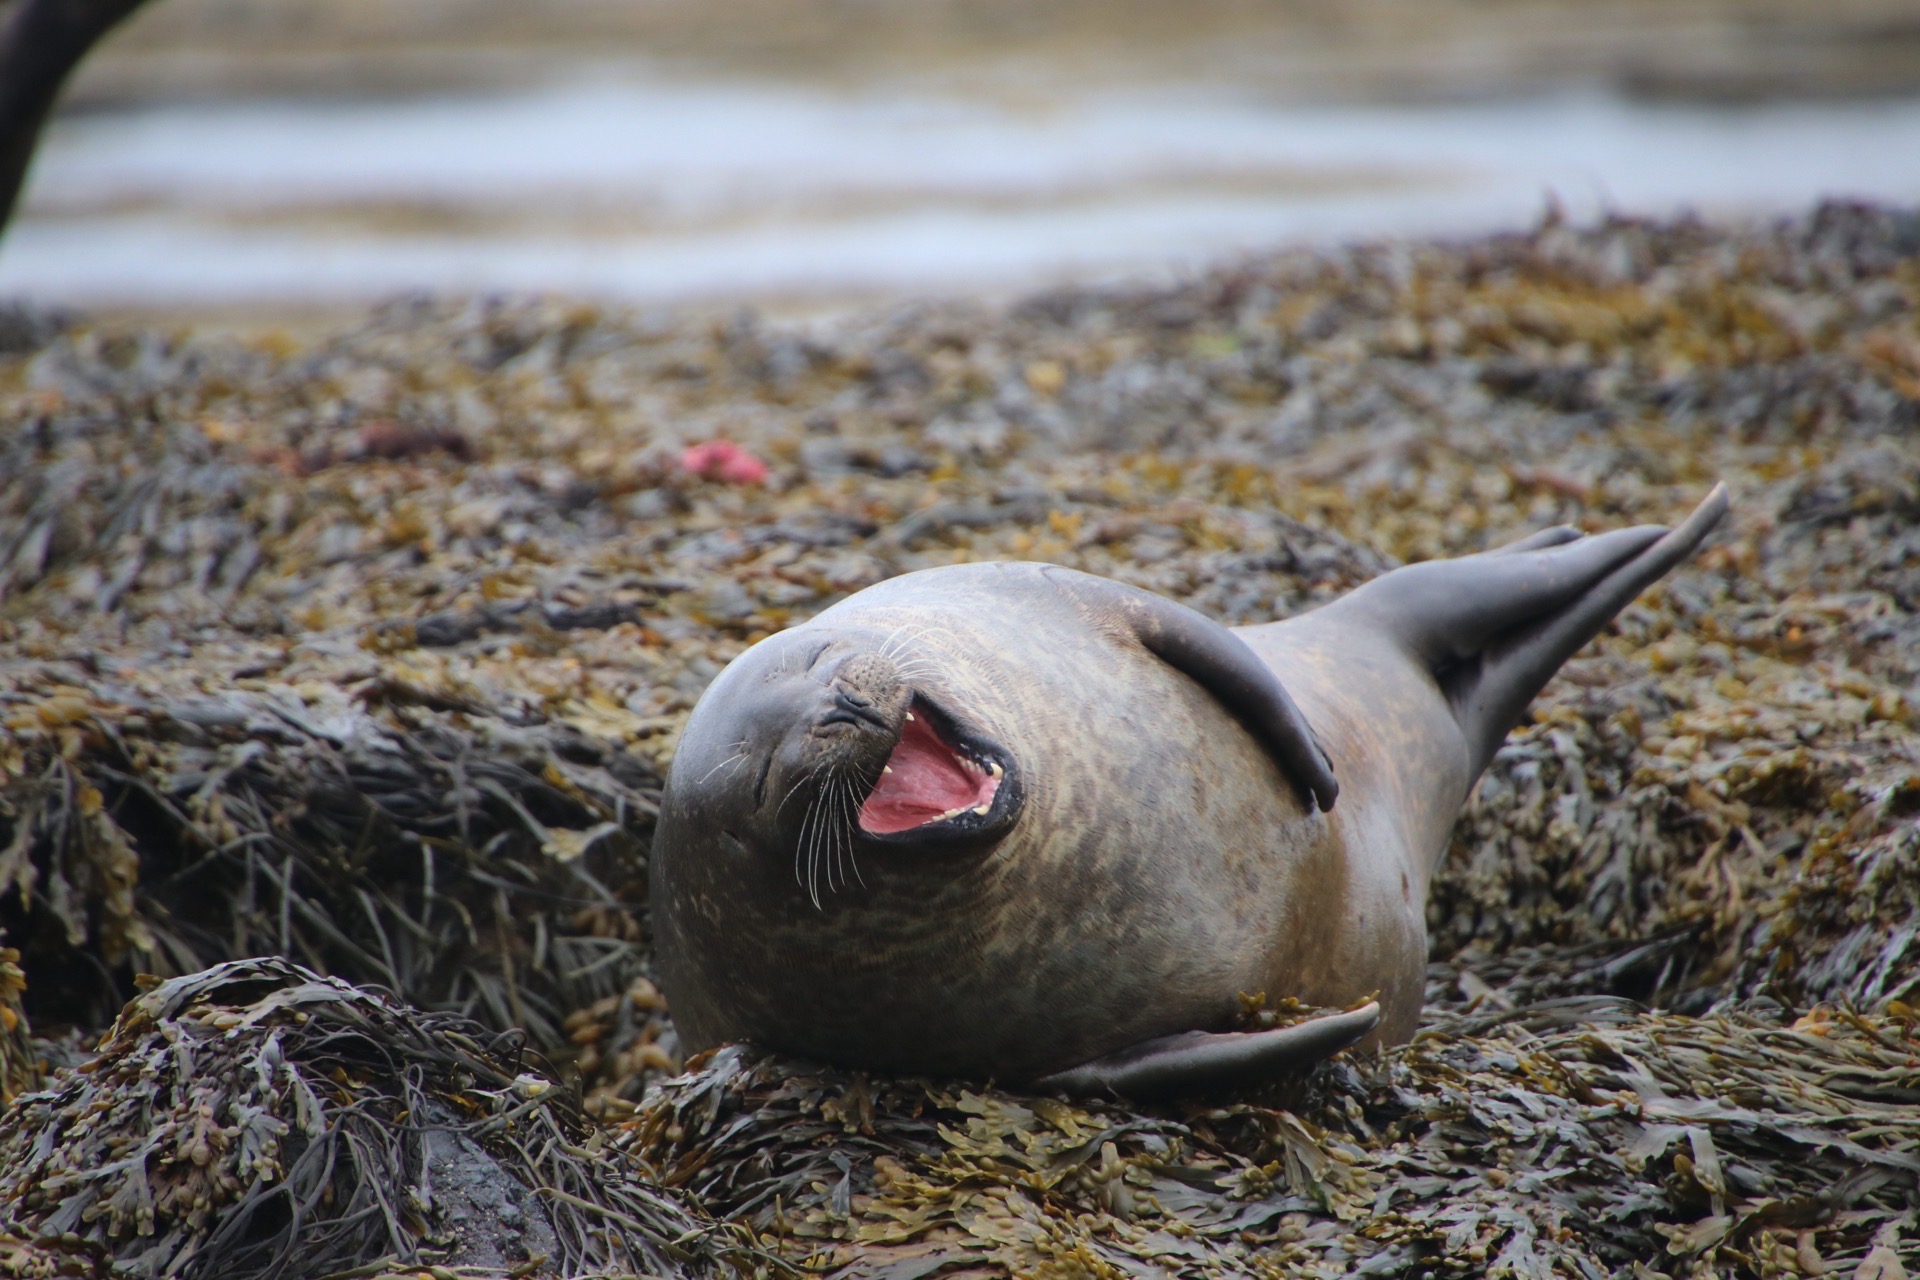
[75,0,1920,104]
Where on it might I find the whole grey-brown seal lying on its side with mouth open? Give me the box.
[651,486,1728,1098]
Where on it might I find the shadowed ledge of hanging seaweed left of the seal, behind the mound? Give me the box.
[0,666,675,1048]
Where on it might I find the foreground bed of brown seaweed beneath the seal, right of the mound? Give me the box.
[633,996,1920,1280]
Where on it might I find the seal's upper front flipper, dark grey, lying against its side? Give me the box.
[1044,566,1340,814]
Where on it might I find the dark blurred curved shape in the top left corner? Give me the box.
[0,0,146,232]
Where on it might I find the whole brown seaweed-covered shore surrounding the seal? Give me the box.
[0,205,1920,1280]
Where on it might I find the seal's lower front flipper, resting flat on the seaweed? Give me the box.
[1033,1002,1380,1102]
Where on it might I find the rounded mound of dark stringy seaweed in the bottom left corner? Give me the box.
[0,960,751,1280]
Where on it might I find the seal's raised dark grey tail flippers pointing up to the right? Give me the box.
[1348,484,1728,775]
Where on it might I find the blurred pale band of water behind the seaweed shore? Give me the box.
[0,73,1920,307]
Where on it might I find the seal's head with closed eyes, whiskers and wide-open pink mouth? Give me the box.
[670,629,1021,910]
